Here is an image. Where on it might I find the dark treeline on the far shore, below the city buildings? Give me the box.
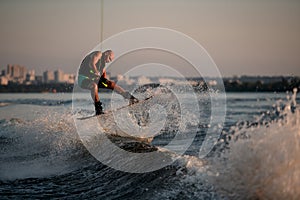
[0,77,300,93]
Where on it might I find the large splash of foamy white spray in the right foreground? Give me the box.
[212,91,300,199]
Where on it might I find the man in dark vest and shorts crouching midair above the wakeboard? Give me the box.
[78,50,138,115]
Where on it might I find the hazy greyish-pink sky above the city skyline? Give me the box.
[0,0,300,77]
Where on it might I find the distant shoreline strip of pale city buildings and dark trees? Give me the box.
[0,65,300,92]
